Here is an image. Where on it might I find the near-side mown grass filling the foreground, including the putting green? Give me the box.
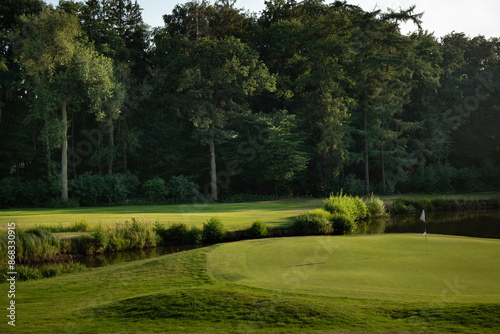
[6,235,500,333]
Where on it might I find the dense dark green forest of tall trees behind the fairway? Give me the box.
[0,0,500,207]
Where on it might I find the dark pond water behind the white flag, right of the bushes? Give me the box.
[362,210,500,238]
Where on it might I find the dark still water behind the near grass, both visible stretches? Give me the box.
[69,210,500,267]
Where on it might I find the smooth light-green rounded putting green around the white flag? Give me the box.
[208,234,500,304]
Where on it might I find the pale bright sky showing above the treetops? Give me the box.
[46,0,500,38]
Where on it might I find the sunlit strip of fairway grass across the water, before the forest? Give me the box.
[0,199,323,230]
